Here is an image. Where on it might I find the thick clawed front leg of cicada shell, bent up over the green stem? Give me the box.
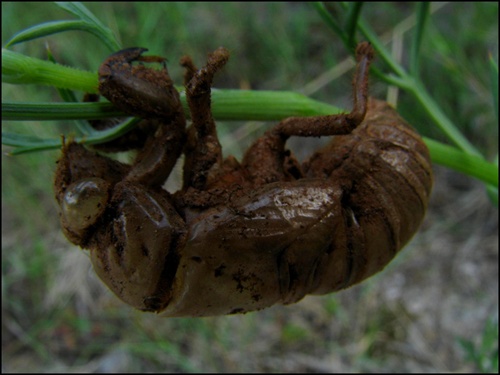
[99,48,186,187]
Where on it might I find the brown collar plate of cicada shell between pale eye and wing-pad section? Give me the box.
[88,182,187,311]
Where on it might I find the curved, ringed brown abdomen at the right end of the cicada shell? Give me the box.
[306,99,433,294]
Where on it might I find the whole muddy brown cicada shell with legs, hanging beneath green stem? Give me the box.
[54,43,432,316]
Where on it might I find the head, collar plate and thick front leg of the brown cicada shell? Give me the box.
[54,49,193,311]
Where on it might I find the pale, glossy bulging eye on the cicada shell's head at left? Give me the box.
[62,178,110,231]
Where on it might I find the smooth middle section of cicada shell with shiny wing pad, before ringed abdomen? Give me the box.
[162,180,347,316]
